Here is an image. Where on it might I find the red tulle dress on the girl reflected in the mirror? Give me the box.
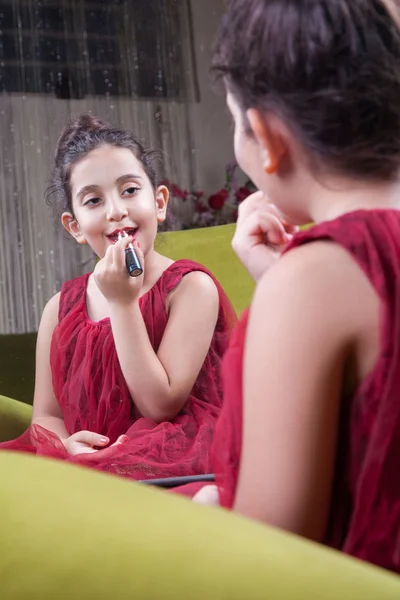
[0,260,235,480]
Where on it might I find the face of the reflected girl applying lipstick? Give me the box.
[62,145,168,258]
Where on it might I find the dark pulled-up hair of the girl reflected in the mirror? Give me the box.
[46,113,162,214]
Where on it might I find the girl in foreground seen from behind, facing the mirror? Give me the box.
[192,0,400,572]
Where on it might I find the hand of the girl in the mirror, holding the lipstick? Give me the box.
[93,237,144,305]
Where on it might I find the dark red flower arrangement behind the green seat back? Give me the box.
[164,162,256,229]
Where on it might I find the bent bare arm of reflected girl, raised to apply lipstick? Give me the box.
[110,271,219,422]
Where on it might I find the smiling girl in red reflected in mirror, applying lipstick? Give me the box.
[2,114,233,479]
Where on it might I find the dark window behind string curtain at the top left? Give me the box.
[0,0,194,99]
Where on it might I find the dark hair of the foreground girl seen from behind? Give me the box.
[213,0,400,180]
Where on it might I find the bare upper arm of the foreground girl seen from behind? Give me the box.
[234,242,379,540]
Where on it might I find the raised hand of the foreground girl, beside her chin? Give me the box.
[232,192,297,281]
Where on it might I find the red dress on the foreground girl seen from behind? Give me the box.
[212,210,400,572]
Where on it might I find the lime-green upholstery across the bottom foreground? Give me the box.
[0,452,400,600]
